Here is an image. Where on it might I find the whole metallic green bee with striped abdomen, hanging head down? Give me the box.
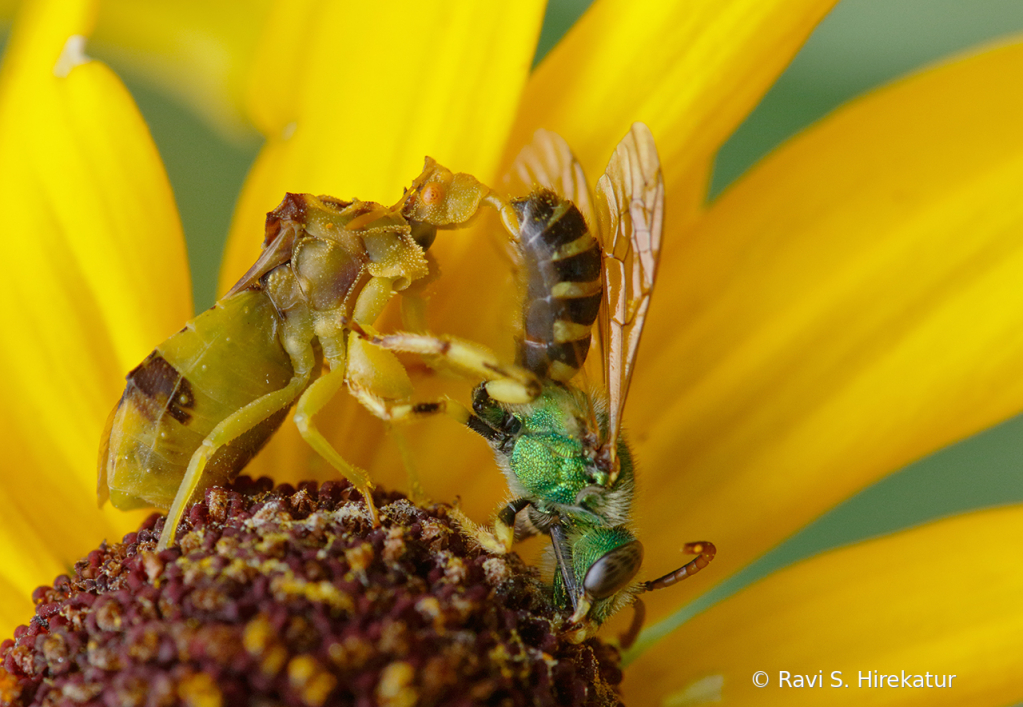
[466,123,716,643]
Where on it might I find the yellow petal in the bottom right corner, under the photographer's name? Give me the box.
[624,505,1023,707]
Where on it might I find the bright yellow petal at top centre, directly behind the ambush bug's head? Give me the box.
[221,0,543,291]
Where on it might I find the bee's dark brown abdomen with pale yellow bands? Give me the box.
[512,189,602,382]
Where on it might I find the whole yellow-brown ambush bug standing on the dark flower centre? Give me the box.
[97,158,536,549]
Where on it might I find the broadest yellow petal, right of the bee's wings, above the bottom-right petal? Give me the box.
[626,36,1023,614]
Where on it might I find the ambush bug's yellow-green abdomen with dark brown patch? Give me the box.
[99,290,293,510]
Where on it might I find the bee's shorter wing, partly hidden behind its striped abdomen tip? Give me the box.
[504,129,594,228]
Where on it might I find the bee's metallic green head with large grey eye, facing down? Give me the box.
[553,526,643,625]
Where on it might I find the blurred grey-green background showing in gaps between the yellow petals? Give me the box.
[7,0,1023,612]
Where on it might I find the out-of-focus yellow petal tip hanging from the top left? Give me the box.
[90,0,271,139]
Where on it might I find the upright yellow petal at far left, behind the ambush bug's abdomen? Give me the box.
[0,2,190,634]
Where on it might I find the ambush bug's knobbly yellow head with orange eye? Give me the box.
[394,158,490,240]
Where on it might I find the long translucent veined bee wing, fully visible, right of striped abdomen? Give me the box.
[594,123,664,483]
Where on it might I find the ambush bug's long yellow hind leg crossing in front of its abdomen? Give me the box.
[157,372,311,550]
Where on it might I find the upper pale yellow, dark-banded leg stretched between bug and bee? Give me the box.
[352,325,540,404]
